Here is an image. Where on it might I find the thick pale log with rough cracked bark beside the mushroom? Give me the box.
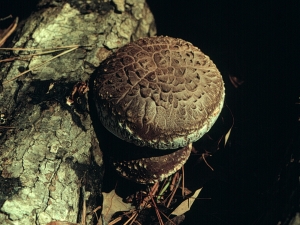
[0,0,155,225]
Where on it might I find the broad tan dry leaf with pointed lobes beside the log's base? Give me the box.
[102,190,134,223]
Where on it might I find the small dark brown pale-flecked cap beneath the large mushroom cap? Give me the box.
[113,143,192,184]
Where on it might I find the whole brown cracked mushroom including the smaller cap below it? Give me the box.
[93,36,225,183]
